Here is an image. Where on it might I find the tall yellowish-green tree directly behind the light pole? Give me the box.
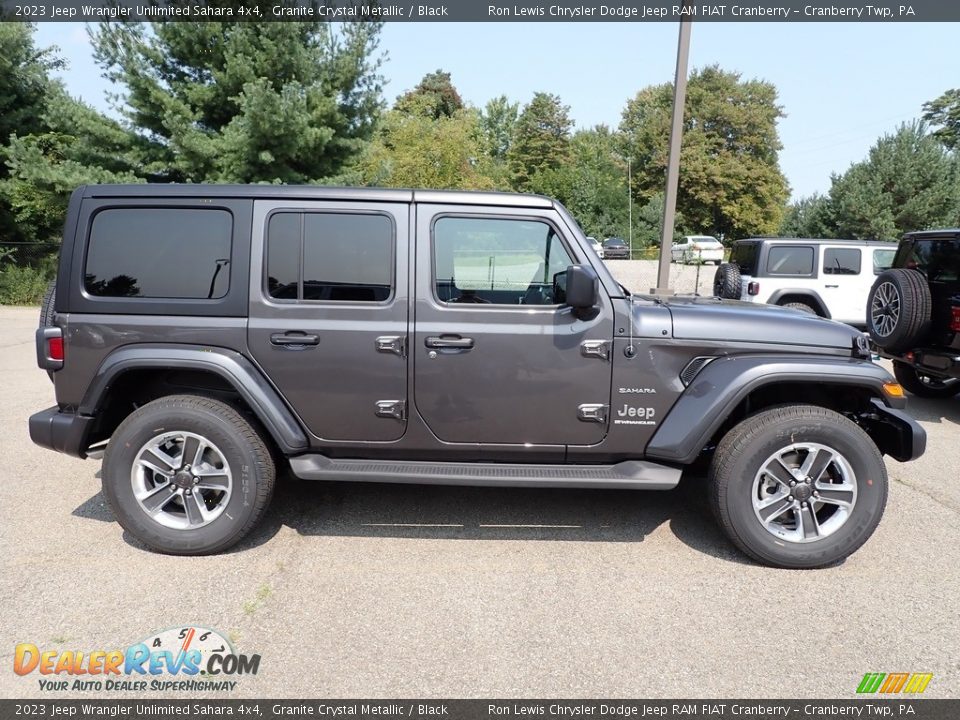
[620,66,788,239]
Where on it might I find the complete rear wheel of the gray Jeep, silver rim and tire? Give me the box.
[102,395,276,555]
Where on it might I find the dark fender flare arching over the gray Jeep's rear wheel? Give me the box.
[77,344,308,455]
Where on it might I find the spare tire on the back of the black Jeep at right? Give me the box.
[866,268,932,353]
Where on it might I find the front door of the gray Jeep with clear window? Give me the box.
[410,204,613,446]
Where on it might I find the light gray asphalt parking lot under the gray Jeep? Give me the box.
[0,300,960,698]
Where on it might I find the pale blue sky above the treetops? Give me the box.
[37,22,960,199]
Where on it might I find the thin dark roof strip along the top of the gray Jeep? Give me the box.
[81,183,555,208]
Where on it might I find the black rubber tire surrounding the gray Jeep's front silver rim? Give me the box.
[708,405,887,568]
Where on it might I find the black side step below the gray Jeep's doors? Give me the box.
[290,455,683,490]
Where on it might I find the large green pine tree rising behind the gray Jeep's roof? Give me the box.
[92,21,381,183]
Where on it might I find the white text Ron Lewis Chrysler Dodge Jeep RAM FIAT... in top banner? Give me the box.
[487,4,914,20]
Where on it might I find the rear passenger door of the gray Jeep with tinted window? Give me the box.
[247,200,409,442]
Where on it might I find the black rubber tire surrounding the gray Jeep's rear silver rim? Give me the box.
[102,395,276,555]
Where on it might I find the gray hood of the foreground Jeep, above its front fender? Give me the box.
[666,296,861,350]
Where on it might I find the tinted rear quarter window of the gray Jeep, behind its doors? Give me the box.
[83,207,233,300]
